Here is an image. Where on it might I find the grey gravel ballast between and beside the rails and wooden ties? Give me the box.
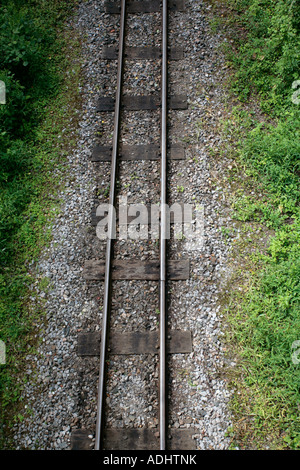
[13,0,236,450]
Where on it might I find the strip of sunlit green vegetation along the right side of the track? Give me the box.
[214,0,300,449]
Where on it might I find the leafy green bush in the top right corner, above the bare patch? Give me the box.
[229,0,300,112]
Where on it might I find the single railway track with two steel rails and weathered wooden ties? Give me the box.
[71,0,195,450]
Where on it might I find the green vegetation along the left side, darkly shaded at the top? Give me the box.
[0,0,80,441]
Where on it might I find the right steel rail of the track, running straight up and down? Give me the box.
[159,0,168,450]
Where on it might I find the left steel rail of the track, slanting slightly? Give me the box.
[95,0,126,450]
